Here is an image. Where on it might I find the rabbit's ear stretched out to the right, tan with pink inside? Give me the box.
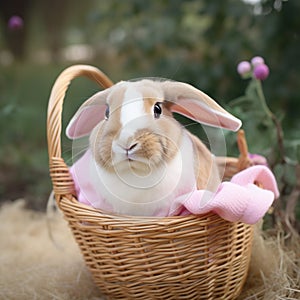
[161,81,242,131]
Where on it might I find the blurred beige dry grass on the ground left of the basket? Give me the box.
[0,201,101,300]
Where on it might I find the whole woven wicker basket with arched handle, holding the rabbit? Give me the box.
[47,65,253,300]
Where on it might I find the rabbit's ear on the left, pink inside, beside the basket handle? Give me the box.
[66,89,109,139]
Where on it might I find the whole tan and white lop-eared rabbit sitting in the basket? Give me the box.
[66,79,241,216]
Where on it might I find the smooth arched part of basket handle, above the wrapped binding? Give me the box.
[47,65,113,160]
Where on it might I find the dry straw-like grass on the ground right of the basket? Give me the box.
[239,221,300,300]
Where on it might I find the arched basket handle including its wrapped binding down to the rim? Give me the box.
[47,65,113,200]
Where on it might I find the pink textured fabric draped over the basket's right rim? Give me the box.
[169,166,279,224]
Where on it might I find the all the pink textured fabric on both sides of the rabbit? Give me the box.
[70,151,279,224]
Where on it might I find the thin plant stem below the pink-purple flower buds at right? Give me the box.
[254,79,286,163]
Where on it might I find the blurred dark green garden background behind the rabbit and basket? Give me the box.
[0,0,300,220]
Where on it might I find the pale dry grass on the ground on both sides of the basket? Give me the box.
[0,201,300,300]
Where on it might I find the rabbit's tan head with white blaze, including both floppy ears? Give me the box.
[67,79,241,174]
